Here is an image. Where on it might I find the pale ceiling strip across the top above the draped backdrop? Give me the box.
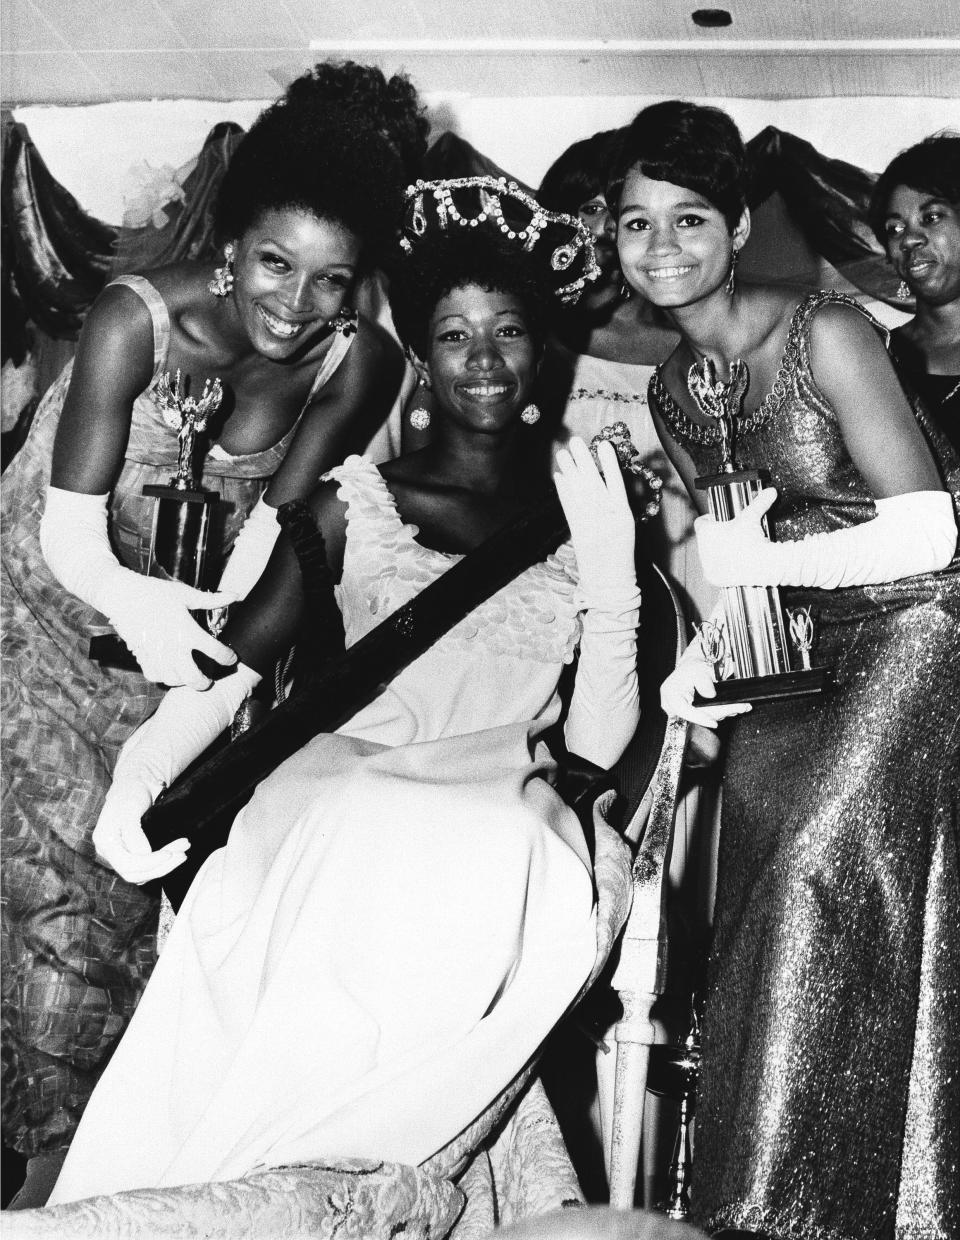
[0,0,960,105]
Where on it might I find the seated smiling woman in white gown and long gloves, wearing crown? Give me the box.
[45,203,639,1220]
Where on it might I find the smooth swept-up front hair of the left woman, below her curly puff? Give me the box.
[213,67,403,267]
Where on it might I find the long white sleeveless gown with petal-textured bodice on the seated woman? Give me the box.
[48,458,597,1205]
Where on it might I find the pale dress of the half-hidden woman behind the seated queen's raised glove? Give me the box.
[561,353,713,620]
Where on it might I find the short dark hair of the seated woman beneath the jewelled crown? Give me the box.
[389,228,553,360]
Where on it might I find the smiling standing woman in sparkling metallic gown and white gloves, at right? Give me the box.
[619,102,960,1240]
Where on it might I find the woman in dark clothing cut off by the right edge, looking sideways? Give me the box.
[869,134,960,451]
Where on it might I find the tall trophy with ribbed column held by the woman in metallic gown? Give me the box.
[687,358,832,706]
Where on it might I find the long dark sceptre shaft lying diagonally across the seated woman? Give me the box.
[143,492,567,908]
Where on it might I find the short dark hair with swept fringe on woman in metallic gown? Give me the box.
[607,99,749,232]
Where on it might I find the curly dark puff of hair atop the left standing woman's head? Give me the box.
[277,61,430,181]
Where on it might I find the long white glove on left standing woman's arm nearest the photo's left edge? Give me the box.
[40,486,237,688]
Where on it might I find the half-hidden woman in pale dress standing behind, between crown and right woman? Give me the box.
[537,129,711,619]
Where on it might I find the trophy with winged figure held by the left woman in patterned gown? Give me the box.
[89,370,223,670]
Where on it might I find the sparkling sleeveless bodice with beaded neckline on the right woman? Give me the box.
[650,290,886,538]
